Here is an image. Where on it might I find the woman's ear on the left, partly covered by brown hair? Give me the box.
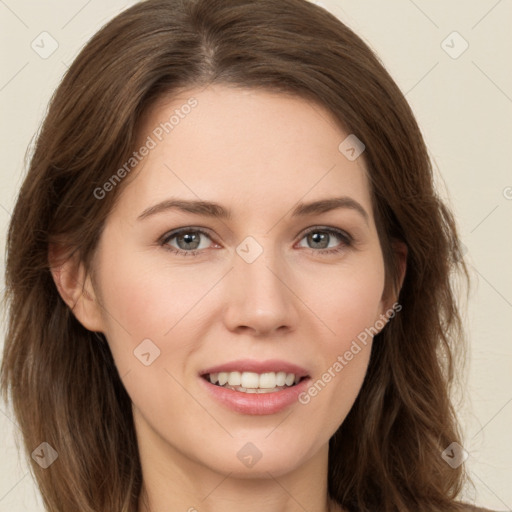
[48,244,103,332]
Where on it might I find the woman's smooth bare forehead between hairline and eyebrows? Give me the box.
[116,85,371,221]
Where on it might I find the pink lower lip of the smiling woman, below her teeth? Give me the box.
[200,377,311,415]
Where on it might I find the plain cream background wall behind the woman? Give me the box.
[0,0,512,512]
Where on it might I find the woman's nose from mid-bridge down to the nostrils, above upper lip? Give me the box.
[223,246,300,337]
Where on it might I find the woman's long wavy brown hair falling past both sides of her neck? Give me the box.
[1,0,467,512]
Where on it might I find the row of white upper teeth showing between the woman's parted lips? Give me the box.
[209,372,301,393]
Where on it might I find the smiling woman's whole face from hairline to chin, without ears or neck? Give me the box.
[85,86,389,477]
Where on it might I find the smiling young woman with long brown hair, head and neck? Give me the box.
[2,0,492,512]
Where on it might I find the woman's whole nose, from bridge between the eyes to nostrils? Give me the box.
[225,237,298,334]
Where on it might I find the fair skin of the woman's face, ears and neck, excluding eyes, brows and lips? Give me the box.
[54,85,406,512]
